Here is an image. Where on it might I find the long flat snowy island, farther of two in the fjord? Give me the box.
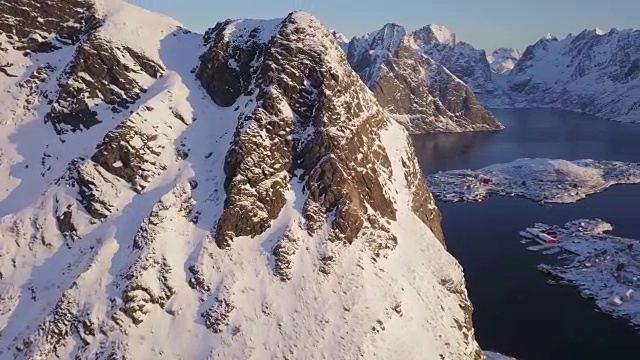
[427,158,640,203]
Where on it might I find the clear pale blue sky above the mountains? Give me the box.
[129,0,640,49]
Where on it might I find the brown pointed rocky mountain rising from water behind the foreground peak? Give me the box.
[347,24,502,133]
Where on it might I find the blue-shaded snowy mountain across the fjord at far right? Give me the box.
[492,29,640,122]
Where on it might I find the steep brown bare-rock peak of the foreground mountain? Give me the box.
[197,12,440,248]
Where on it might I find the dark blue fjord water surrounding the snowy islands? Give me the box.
[413,109,640,360]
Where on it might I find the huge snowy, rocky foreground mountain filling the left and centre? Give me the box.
[0,0,484,360]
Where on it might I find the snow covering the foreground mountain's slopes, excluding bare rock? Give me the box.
[0,1,478,360]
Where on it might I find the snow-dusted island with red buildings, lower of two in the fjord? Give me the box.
[520,219,640,325]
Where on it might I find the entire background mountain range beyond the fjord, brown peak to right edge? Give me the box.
[348,24,640,125]
